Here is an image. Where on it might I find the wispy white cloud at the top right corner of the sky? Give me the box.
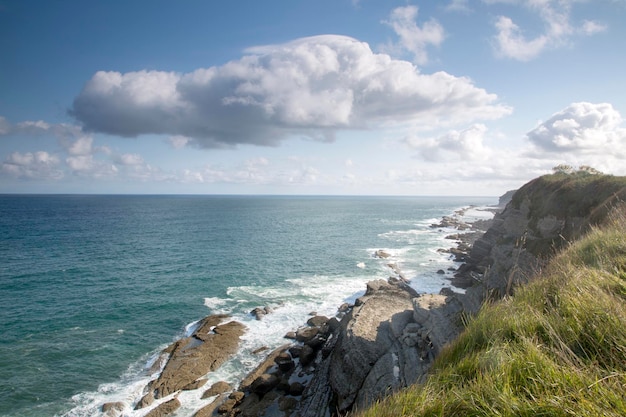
[490,0,607,61]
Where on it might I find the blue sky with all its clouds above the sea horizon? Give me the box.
[0,0,626,196]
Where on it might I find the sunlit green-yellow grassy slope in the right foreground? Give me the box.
[361,204,626,417]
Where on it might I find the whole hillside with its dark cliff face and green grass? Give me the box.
[359,172,626,417]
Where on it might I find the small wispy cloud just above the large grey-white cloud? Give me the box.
[383,2,444,65]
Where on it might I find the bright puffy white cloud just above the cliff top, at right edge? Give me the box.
[527,102,626,157]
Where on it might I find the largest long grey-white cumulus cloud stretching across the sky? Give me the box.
[70,35,511,148]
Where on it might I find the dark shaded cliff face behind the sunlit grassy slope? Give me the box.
[462,175,626,299]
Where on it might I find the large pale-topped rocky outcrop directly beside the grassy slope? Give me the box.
[298,280,454,417]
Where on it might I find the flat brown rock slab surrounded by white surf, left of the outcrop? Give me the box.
[151,315,245,398]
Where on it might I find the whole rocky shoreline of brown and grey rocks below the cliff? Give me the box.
[102,204,498,417]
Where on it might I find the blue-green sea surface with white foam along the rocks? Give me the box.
[0,195,497,417]
